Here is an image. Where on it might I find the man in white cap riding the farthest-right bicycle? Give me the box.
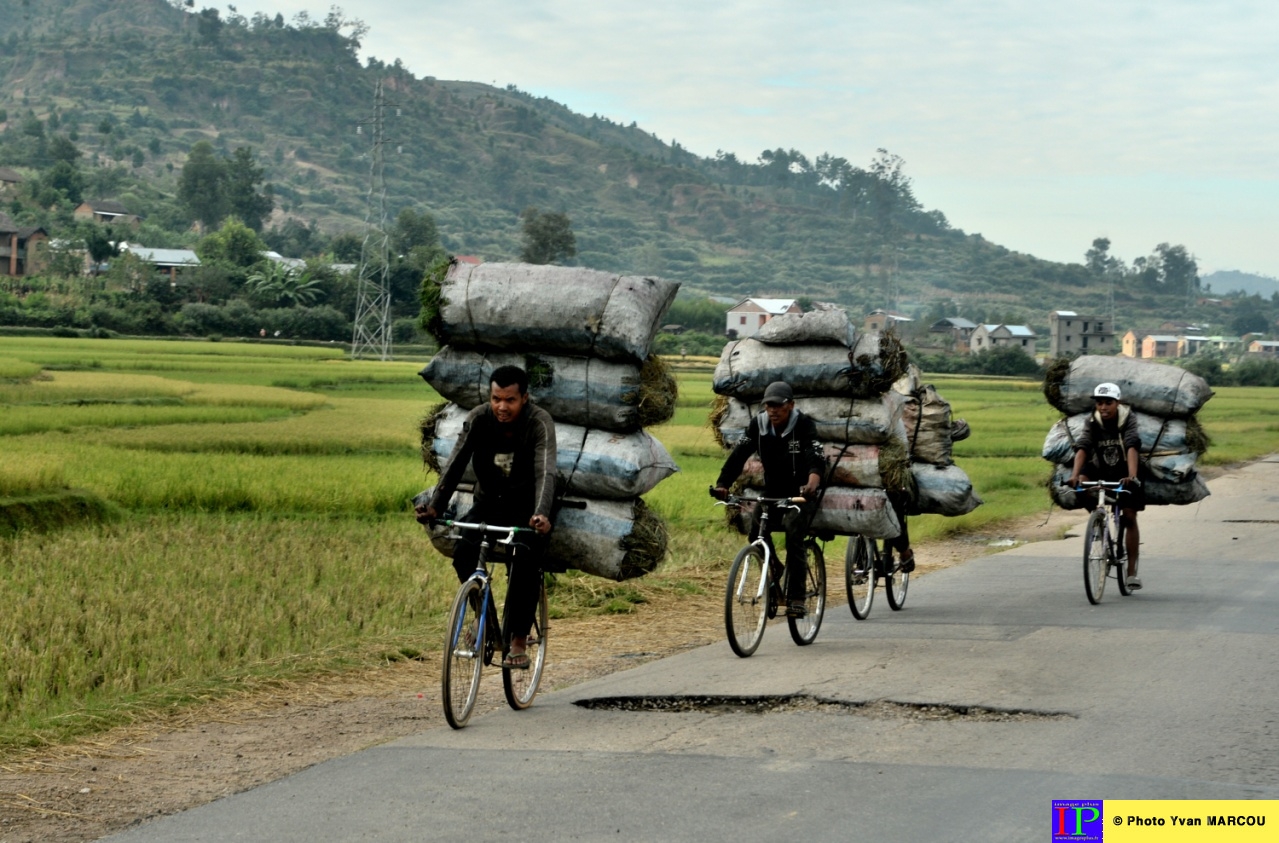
[1068,384,1146,591]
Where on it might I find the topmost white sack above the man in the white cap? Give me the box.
[1044,354,1212,418]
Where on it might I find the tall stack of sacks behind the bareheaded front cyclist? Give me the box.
[421,262,679,579]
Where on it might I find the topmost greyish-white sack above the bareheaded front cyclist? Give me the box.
[428,264,679,363]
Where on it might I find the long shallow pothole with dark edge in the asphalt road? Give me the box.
[574,693,1076,723]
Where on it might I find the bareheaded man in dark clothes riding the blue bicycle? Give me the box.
[413,366,555,669]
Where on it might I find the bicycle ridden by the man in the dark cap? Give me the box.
[711,487,826,659]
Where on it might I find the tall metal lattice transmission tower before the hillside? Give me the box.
[350,79,399,359]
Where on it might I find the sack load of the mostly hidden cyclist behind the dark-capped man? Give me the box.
[893,363,982,517]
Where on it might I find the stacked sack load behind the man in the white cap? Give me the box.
[1044,356,1212,509]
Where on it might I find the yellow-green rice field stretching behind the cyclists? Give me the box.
[0,338,1279,753]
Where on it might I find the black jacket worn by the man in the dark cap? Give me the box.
[715,409,826,498]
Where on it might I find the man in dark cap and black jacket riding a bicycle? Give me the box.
[712,381,826,618]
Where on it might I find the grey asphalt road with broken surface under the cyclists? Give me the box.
[109,459,1279,843]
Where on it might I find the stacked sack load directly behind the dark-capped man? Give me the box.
[711,310,913,539]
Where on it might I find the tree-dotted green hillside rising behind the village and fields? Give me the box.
[0,0,1248,335]
